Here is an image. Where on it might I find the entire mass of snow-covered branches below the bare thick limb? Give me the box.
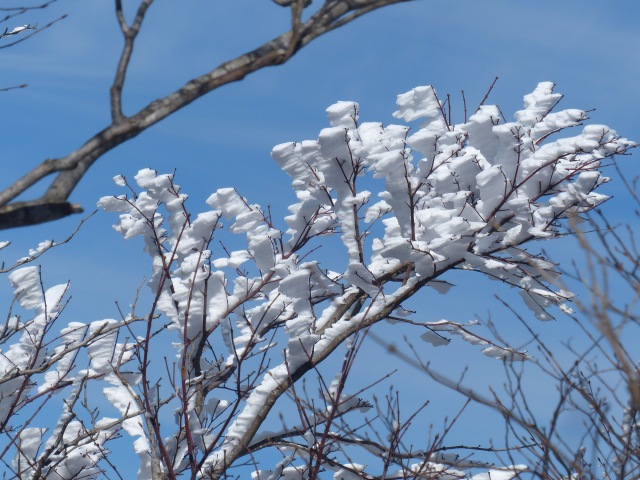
[0,83,635,480]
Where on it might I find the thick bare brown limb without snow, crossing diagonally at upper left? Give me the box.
[0,0,411,229]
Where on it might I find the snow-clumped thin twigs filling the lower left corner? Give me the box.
[0,264,140,479]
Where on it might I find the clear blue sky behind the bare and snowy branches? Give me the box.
[0,0,640,476]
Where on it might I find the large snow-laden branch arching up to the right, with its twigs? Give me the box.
[99,82,636,478]
